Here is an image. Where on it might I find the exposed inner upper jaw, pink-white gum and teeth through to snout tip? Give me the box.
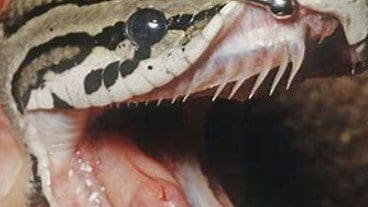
[130,4,367,103]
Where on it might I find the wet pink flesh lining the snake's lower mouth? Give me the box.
[33,105,231,207]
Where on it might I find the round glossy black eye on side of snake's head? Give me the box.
[126,8,168,46]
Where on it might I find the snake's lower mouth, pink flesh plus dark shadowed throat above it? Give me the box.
[28,101,239,207]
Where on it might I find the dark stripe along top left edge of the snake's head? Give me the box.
[4,0,111,37]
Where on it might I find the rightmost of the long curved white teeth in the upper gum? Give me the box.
[286,40,305,90]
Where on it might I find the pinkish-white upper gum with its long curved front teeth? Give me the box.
[162,4,306,105]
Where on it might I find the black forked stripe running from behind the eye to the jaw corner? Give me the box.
[12,22,126,111]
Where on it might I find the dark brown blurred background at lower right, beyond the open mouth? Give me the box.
[207,75,368,207]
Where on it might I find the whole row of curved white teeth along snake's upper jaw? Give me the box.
[121,37,305,107]
